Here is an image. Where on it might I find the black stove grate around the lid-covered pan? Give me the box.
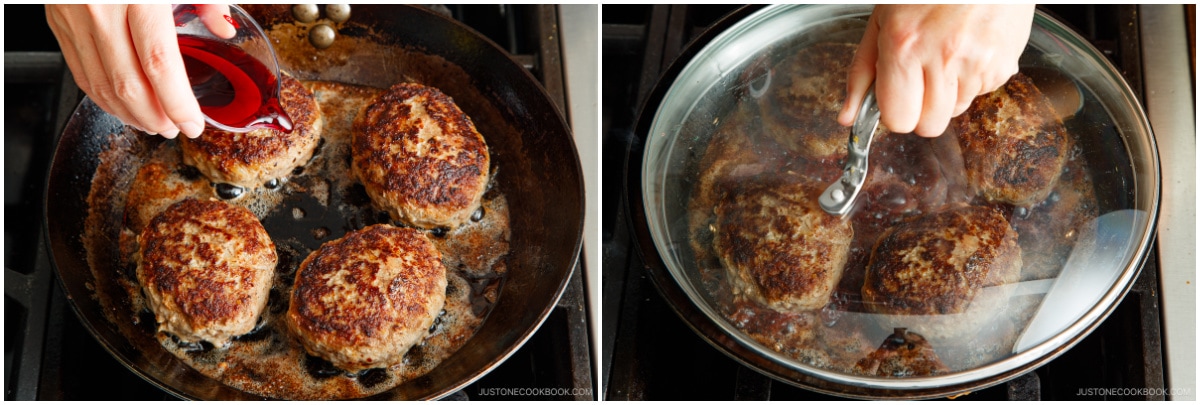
[601,5,1164,400]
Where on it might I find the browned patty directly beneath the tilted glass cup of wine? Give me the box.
[180,74,323,188]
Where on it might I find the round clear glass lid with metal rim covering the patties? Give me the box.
[642,5,1159,389]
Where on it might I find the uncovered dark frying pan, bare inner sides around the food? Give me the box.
[46,5,583,400]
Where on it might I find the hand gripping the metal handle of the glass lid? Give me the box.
[838,5,1034,137]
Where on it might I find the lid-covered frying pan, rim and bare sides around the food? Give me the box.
[625,5,1162,398]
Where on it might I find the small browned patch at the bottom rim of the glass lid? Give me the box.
[854,328,949,377]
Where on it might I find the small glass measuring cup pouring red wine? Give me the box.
[173,5,292,132]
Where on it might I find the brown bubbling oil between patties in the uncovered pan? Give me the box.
[89,81,510,399]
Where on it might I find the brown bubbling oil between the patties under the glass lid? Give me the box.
[685,93,1097,375]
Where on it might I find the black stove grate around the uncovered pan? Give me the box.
[4,5,595,400]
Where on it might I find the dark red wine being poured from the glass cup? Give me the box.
[179,35,292,132]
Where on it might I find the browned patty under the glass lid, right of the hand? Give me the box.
[950,73,1068,206]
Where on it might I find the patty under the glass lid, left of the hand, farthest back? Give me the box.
[751,43,857,158]
